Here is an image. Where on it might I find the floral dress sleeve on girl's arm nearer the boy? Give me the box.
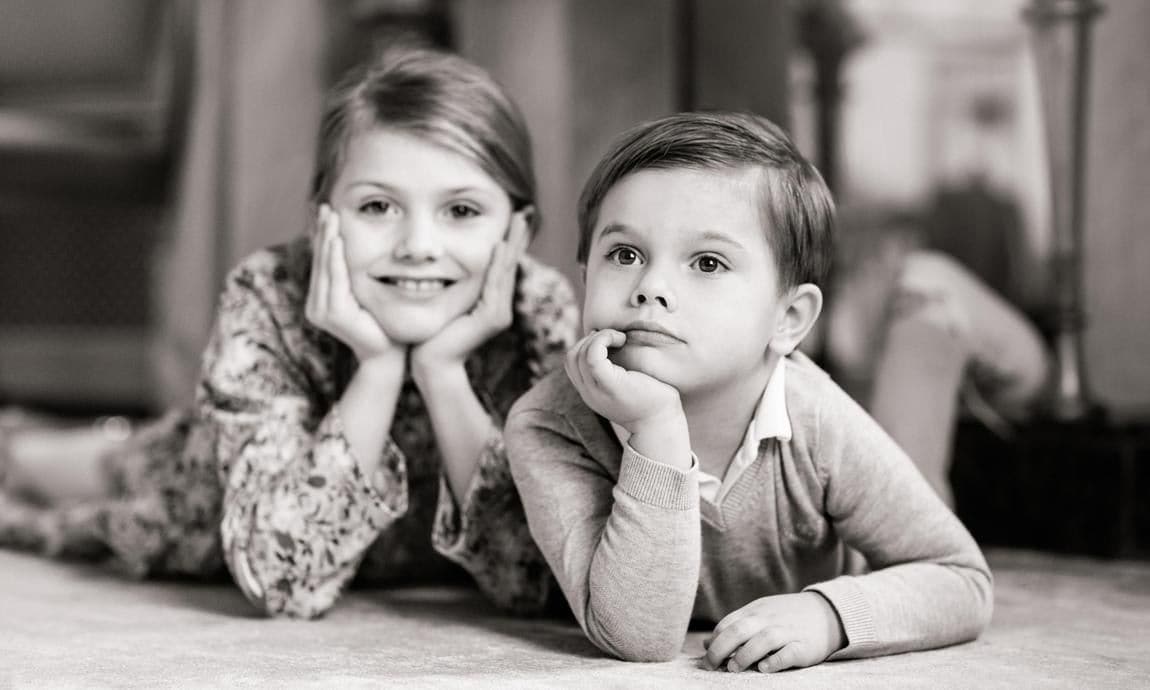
[431,259,578,614]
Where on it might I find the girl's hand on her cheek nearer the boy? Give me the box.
[412,212,528,383]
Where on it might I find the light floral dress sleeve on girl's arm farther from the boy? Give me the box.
[197,258,407,618]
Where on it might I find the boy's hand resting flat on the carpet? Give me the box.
[703,592,846,673]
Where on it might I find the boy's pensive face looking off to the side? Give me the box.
[583,169,785,396]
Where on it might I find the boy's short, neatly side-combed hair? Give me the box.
[578,113,835,290]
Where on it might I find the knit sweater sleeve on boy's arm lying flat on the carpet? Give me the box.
[807,381,992,659]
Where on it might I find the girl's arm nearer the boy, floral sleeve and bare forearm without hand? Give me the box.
[425,258,577,613]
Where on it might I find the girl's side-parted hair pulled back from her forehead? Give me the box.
[312,46,539,232]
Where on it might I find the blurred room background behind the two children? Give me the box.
[0,0,1150,553]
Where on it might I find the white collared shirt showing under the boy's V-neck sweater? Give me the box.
[611,360,791,506]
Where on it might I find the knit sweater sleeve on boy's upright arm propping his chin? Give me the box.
[506,406,700,661]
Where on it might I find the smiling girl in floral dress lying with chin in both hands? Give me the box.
[0,49,576,618]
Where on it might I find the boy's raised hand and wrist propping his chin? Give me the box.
[566,329,691,469]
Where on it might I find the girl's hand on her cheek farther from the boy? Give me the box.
[304,204,397,362]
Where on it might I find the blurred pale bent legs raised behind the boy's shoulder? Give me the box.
[822,206,1050,505]
